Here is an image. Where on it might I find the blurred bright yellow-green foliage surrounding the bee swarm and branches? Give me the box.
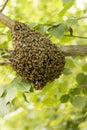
[0,0,87,130]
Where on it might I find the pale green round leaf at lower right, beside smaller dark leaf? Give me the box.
[71,96,86,108]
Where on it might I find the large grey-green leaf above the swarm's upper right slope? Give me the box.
[48,24,67,39]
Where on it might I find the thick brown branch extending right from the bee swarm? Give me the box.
[59,44,87,56]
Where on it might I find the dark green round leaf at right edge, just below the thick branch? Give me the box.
[76,73,87,85]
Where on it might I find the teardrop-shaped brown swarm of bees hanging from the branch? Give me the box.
[9,22,65,89]
